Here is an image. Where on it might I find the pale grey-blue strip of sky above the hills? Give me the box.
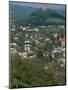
[10,1,65,10]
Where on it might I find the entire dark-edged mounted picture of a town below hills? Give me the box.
[9,1,66,88]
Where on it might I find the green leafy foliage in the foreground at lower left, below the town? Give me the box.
[11,54,63,88]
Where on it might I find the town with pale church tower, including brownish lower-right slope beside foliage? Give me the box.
[10,25,66,87]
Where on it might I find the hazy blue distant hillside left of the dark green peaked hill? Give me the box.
[10,5,37,21]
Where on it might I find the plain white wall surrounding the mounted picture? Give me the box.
[0,0,68,90]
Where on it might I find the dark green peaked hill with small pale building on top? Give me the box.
[26,8,65,25]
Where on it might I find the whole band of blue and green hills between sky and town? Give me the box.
[10,5,65,25]
